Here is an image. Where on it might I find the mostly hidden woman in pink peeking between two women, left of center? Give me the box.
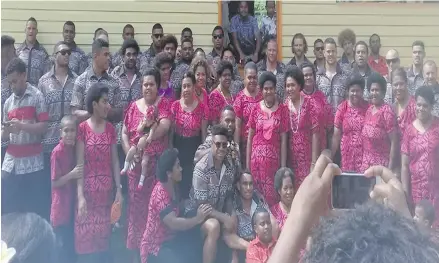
[190,58,210,108]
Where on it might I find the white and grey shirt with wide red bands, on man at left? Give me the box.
[2,83,49,174]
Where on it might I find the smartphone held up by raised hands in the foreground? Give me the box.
[331,173,376,209]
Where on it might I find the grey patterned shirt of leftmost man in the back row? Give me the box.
[16,41,50,86]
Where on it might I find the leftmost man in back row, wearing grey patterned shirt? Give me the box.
[17,17,50,86]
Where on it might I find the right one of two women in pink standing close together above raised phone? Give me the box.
[360,72,399,172]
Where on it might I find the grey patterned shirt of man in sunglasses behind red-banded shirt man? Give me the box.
[38,67,78,153]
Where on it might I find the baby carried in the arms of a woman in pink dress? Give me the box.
[120,105,158,190]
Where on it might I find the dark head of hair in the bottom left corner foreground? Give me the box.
[1,213,57,263]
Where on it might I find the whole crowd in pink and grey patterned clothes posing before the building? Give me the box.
[1,1,439,263]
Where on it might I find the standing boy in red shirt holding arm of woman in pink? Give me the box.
[50,115,83,262]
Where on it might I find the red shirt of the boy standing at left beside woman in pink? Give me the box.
[50,141,76,227]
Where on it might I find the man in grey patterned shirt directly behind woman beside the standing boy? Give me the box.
[70,39,123,123]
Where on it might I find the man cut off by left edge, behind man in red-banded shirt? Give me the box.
[1,35,17,163]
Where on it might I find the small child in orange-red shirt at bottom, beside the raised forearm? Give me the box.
[246,207,276,263]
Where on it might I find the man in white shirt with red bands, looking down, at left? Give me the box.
[1,58,50,219]
